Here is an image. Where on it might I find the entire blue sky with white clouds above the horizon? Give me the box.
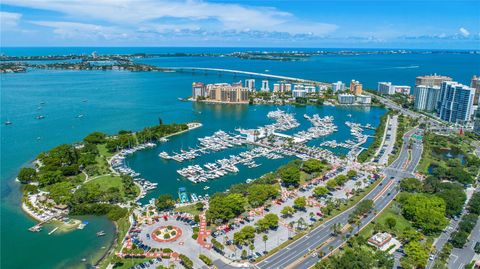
[0,0,480,49]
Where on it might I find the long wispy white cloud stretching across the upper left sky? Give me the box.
[3,0,337,35]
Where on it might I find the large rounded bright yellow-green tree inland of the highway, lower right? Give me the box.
[401,193,448,234]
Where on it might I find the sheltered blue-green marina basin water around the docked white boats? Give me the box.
[126,104,386,200]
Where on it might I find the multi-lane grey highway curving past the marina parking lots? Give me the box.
[256,129,423,269]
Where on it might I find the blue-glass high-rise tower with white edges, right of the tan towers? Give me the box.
[437,81,475,124]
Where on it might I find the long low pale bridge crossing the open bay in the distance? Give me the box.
[164,67,330,85]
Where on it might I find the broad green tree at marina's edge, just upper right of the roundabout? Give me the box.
[206,193,247,223]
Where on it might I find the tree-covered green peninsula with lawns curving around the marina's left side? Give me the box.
[17,121,188,220]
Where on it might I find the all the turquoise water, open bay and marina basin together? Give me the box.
[0,48,480,268]
